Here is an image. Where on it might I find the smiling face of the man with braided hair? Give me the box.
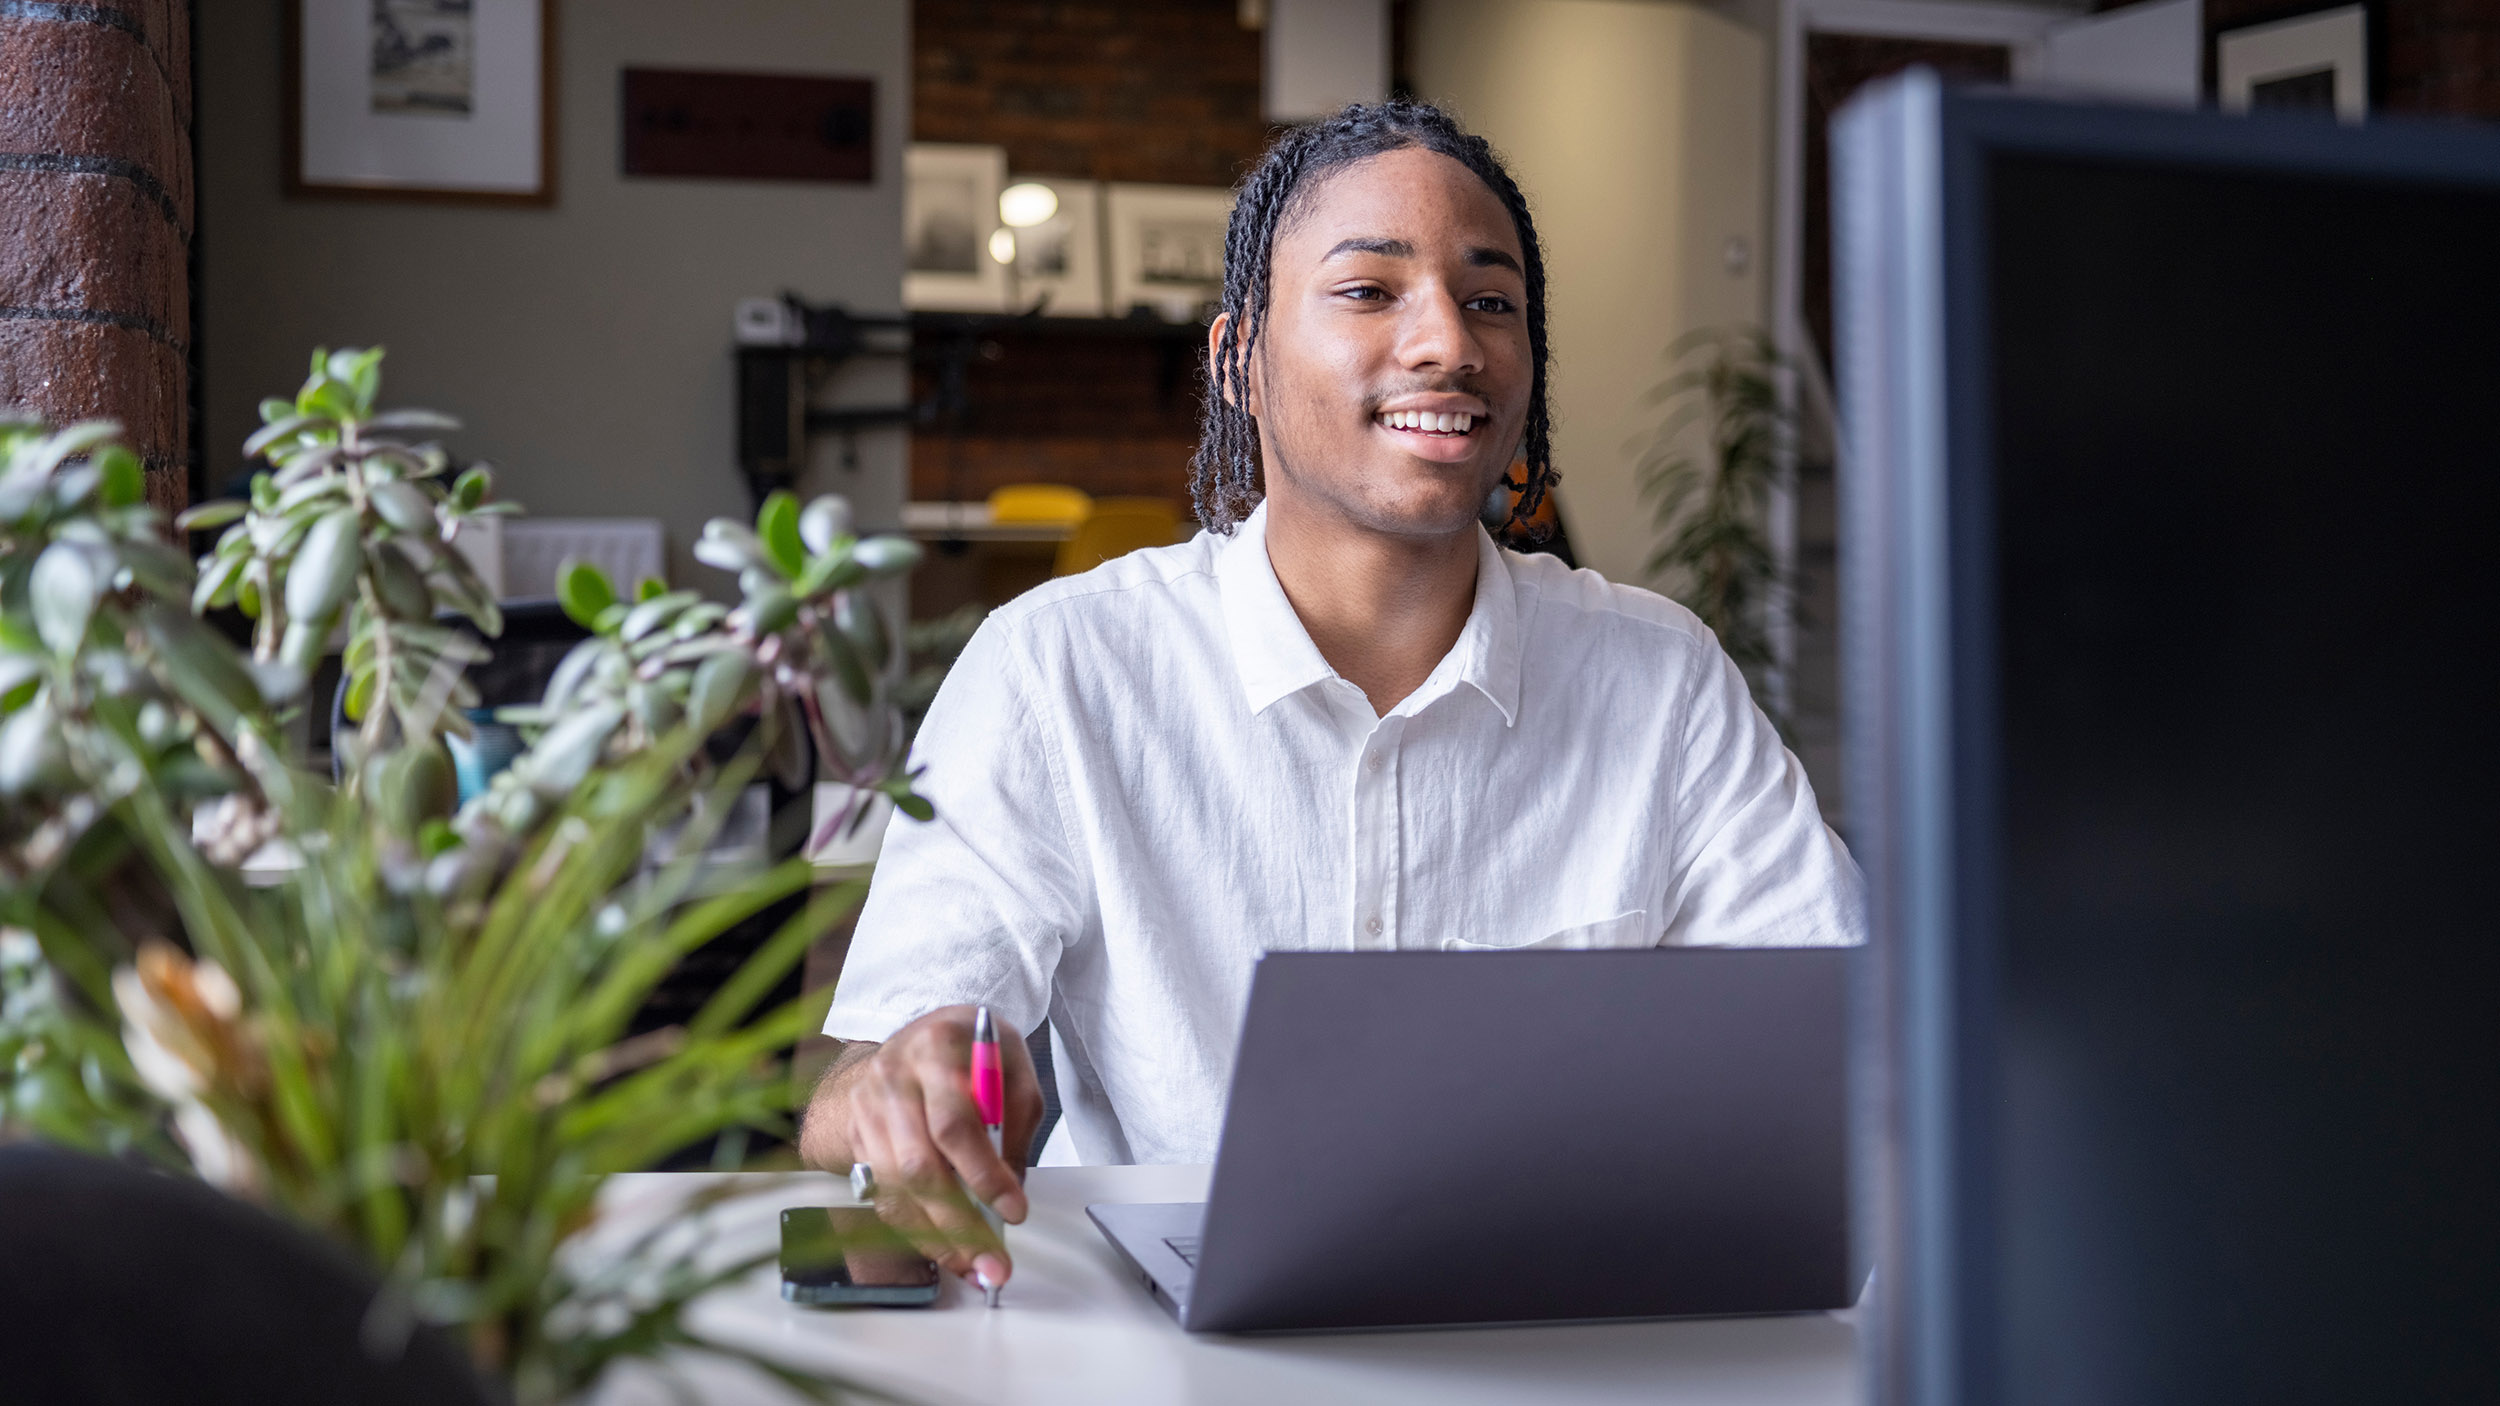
[1250,148,1530,535]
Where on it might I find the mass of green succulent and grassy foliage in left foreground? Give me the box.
[0,350,925,1401]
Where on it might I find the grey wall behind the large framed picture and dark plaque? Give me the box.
[195,0,910,588]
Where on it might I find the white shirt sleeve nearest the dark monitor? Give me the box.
[1660,648,1865,948]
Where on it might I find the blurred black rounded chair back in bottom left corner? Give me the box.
[0,1143,498,1406]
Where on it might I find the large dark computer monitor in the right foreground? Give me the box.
[1835,75,2500,1406]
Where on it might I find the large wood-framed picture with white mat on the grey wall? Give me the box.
[285,0,555,205]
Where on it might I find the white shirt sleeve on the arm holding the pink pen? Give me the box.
[825,618,1088,1041]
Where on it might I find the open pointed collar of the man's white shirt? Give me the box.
[1215,503,1520,726]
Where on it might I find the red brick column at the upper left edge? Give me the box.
[0,0,193,508]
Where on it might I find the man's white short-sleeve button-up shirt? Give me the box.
[825,508,1863,1163]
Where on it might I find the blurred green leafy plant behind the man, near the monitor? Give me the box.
[1638,330,1795,695]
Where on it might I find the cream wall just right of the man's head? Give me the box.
[1408,0,1770,583]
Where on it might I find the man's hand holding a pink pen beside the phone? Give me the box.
[800,1006,1043,1283]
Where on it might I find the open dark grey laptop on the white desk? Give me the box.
[1085,948,1853,1333]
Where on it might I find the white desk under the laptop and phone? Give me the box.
[572,1166,1860,1406]
